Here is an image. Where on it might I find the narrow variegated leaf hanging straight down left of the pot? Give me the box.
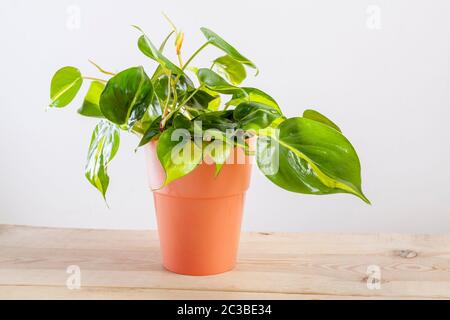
[85,120,120,200]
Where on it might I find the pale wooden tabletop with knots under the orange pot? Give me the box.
[0,225,450,299]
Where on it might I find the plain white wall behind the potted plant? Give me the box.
[0,0,450,233]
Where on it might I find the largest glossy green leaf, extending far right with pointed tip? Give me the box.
[257,118,369,203]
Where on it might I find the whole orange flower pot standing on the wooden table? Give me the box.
[145,142,255,275]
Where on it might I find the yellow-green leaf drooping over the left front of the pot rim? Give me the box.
[156,128,202,188]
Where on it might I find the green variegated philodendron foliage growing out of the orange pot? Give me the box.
[50,18,369,203]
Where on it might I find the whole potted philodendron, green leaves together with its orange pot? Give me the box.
[50,18,369,275]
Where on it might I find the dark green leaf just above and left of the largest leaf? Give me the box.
[233,102,282,130]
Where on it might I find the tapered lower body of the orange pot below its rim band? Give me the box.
[154,192,245,276]
